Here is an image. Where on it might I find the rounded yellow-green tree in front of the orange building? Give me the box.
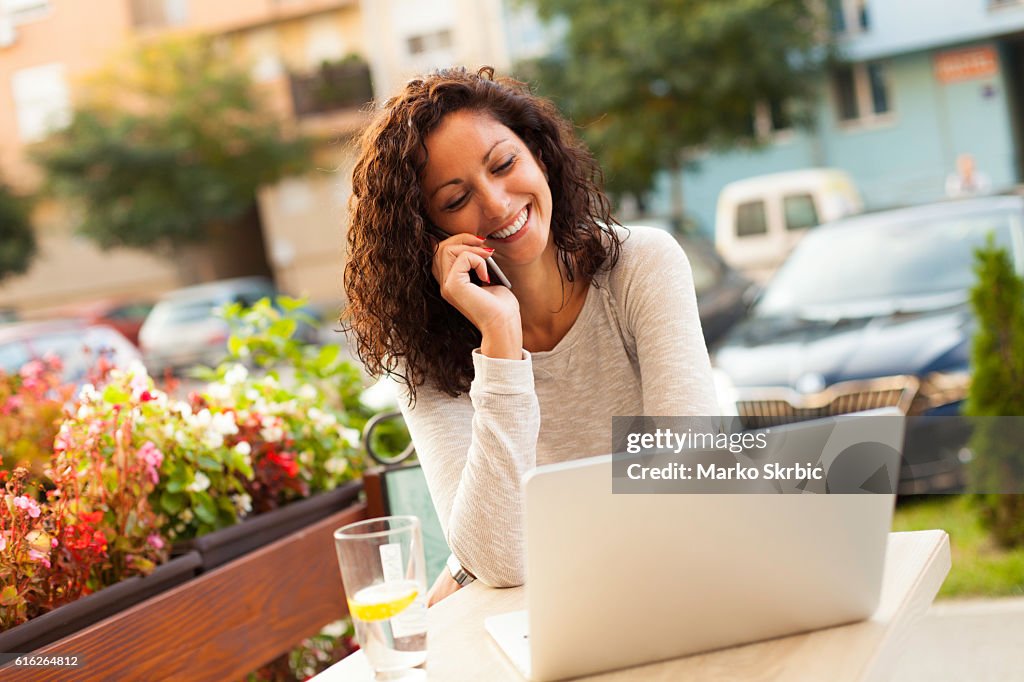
[34,38,310,258]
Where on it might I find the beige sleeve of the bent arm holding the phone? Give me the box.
[400,351,541,587]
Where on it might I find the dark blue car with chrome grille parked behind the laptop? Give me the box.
[714,197,1024,494]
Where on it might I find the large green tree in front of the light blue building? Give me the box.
[523,0,828,209]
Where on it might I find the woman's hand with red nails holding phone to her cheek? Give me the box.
[432,233,522,359]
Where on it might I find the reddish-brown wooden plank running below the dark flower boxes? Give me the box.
[0,503,367,682]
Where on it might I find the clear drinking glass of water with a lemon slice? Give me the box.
[334,516,427,680]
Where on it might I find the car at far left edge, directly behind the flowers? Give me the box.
[0,319,141,384]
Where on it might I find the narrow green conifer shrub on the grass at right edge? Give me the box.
[966,237,1024,547]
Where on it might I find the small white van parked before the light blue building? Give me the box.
[715,168,864,283]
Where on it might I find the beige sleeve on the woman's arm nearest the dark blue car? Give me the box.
[624,229,719,417]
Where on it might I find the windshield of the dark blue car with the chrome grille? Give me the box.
[757,211,1013,315]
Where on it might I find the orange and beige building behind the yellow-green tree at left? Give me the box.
[0,0,373,316]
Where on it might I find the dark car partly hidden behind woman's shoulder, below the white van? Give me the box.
[622,220,758,347]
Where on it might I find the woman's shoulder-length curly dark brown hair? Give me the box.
[341,67,621,400]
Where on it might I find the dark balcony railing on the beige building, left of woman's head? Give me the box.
[289,60,374,118]
